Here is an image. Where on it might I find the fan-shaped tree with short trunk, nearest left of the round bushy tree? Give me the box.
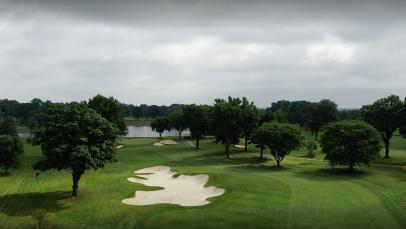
[257,122,303,167]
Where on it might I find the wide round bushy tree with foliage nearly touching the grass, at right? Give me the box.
[320,120,381,170]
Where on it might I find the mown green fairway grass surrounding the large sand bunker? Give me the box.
[0,138,406,229]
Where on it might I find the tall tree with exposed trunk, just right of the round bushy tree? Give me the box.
[361,95,404,158]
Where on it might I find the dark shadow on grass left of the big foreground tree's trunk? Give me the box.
[0,192,71,216]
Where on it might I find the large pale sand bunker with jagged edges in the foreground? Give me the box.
[123,166,224,206]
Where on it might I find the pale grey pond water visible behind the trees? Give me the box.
[18,126,186,138]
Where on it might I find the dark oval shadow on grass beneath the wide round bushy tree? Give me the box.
[295,168,371,181]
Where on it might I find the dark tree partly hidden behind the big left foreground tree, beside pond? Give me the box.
[88,95,128,136]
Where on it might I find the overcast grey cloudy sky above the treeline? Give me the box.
[0,0,406,108]
